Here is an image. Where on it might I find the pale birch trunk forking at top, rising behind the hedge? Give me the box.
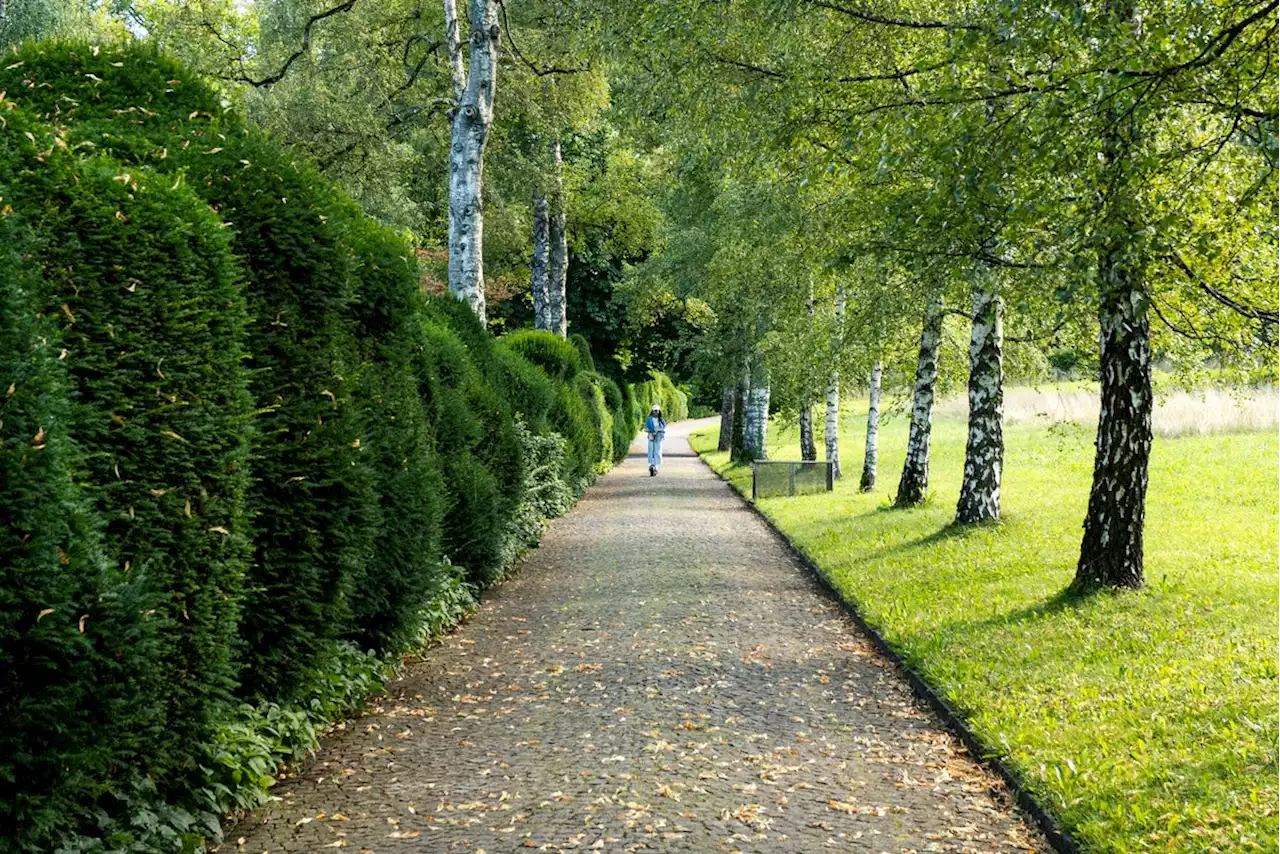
[444,0,499,323]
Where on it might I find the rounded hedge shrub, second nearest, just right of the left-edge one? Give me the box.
[0,110,252,793]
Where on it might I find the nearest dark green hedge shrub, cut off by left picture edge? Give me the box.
[0,215,163,850]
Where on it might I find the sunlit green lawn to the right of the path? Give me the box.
[694,411,1280,851]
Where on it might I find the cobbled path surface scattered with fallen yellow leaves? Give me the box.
[230,423,1048,854]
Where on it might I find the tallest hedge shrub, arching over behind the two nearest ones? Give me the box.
[0,44,378,698]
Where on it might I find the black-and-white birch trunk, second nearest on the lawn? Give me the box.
[956,279,1005,524]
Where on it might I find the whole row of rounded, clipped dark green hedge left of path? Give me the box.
[0,44,669,850]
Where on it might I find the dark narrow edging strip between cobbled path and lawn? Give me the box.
[694,451,1085,854]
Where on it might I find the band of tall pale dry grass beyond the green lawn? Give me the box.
[937,384,1280,437]
